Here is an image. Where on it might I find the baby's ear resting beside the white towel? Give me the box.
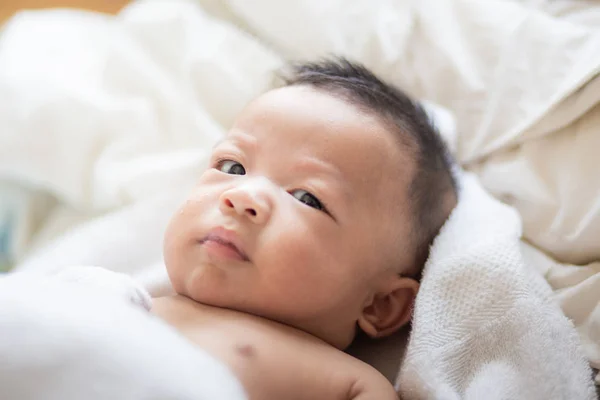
[358,276,419,338]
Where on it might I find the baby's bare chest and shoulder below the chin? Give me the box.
[154,299,397,400]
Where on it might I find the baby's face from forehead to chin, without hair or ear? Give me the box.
[165,86,413,344]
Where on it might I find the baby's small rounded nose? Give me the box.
[219,187,271,224]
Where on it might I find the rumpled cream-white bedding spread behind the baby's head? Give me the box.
[0,0,600,396]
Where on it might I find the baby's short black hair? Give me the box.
[282,57,457,277]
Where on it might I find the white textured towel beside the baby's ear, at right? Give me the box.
[397,176,596,400]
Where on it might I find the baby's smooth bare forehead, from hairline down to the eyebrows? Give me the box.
[232,86,412,195]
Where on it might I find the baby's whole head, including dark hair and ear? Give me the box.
[165,60,457,348]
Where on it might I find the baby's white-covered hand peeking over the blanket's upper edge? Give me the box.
[55,266,152,311]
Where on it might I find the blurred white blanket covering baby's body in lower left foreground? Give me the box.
[0,273,246,400]
